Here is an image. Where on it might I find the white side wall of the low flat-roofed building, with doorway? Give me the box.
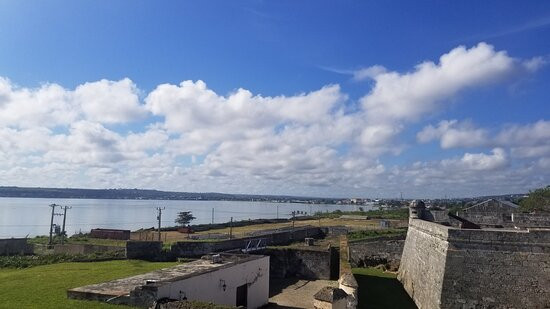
[157,256,269,308]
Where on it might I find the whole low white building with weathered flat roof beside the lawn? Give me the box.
[67,254,269,308]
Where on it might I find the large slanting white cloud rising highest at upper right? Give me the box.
[361,43,521,121]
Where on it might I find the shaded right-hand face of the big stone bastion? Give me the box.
[442,225,550,308]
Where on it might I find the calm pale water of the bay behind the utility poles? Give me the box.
[0,198,370,238]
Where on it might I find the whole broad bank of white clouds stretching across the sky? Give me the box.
[0,43,550,196]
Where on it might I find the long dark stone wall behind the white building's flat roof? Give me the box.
[171,226,326,257]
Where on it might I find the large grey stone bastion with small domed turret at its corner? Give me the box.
[398,200,550,309]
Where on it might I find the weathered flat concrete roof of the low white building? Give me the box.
[67,253,264,300]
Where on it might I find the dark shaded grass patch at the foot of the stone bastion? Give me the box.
[353,268,416,309]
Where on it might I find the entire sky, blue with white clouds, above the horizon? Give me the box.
[0,1,550,197]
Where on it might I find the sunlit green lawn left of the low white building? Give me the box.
[0,260,177,309]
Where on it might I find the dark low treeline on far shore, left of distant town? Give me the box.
[0,187,336,203]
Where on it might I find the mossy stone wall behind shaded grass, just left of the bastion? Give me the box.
[349,235,405,271]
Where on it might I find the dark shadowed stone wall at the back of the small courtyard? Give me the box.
[258,248,338,280]
